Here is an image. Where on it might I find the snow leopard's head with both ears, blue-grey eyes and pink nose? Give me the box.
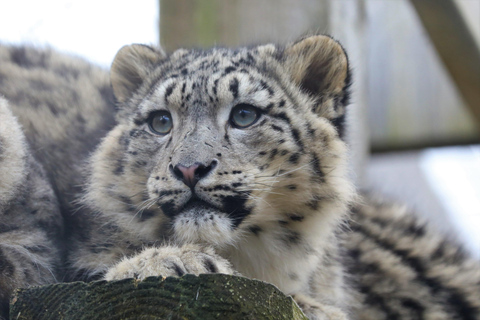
[87,36,352,249]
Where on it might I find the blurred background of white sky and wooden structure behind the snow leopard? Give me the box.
[0,0,480,258]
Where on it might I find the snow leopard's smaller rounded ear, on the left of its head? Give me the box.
[110,44,166,102]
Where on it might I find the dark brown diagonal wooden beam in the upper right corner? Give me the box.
[411,0,480,124]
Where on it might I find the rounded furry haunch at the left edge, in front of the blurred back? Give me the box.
[0,97,63,319]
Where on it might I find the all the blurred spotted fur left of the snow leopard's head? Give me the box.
[0,46,114,319]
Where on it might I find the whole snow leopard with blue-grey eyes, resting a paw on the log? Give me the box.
[0,35,480,320]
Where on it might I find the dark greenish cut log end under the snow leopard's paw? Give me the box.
[10,274,307,320]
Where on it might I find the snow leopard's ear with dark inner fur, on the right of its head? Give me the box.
[284,35,350,119]
